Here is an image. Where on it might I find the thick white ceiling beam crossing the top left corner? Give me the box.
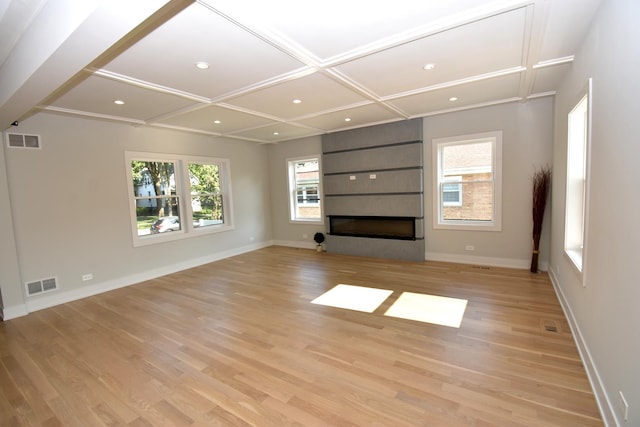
[0,0,192,130]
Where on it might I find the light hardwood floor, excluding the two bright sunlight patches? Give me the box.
[0,247,602,427]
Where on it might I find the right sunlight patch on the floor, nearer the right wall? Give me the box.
[384,292,467,328]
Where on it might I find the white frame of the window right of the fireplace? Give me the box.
[431,131,502,231]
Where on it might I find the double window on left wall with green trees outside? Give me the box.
[125,152,232,246]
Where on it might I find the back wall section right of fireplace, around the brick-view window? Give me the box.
[423,97,553,270]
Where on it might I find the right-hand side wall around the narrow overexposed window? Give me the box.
[550,0,640,426]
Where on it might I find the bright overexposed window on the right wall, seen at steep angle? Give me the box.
[564,81,591,272]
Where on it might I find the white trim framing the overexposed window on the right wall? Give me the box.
[563,78,593,286]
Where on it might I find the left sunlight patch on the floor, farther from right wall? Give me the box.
[311,284,393,313]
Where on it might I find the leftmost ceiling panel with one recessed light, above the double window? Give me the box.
[53,76,194,120]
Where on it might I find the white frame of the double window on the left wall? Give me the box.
[125,151,235,247]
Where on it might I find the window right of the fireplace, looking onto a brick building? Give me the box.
[432,131,502,231]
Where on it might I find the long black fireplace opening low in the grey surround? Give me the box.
[329,215,416,240]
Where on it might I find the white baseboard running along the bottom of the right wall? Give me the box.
[548,269,620,427]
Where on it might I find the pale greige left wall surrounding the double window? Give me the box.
[0,114,271,314]
